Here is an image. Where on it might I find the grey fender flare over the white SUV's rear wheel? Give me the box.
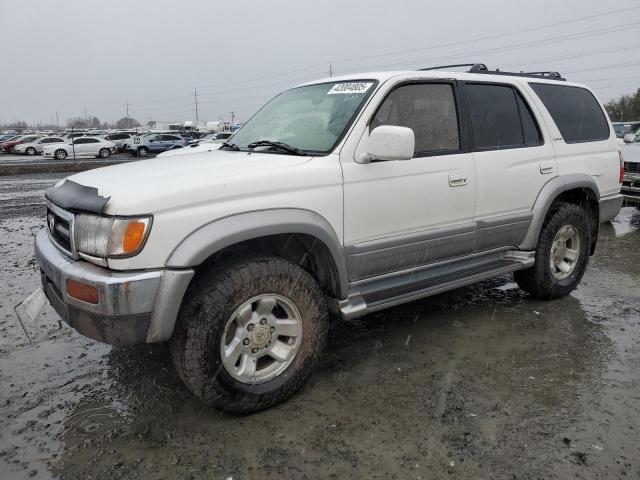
[519,173,600,250]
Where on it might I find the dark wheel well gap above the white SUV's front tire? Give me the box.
[198,233,340,298]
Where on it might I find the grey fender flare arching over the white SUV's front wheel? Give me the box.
[166,208,349,298]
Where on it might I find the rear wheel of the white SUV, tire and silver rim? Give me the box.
[514,203,592,300]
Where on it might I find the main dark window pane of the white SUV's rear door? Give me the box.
[467,84,524,149]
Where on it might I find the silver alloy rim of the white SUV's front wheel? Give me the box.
[220,293,302,384]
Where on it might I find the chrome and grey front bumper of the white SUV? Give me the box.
[35,229,194,345]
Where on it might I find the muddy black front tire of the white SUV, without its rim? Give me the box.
[171,256,328,413]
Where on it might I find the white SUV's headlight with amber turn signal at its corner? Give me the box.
[73,214,151,258]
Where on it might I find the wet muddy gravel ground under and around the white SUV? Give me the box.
[0,175,640,480]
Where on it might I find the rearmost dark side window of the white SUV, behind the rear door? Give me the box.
[529,83,610,143]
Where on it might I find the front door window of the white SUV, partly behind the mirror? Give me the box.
[370,83,460,154]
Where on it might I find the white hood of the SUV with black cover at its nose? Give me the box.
[46,150,312,215]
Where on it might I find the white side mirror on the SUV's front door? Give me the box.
[356,125,416,163]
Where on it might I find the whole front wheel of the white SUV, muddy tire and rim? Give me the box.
[171,256,328,413]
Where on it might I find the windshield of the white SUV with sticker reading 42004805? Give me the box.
[233,80,376,153]
